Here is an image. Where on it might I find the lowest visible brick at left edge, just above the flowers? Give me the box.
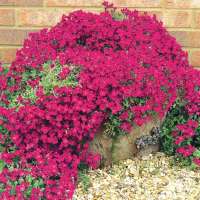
[0,47,17,63]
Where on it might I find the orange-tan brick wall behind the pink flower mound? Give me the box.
[0,0,200,69]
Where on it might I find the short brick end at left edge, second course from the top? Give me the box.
[0,9,15,26]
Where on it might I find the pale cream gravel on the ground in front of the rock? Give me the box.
[74,153,200,200]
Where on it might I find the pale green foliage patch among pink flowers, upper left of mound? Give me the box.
[5,61,80,110]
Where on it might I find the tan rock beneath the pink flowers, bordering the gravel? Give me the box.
[89,118,161,166]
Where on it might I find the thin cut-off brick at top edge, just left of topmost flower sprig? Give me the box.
[46,0,103,7]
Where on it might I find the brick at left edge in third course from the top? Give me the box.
[0,29,36,45]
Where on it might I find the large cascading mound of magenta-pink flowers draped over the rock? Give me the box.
[0,3,200,200]
